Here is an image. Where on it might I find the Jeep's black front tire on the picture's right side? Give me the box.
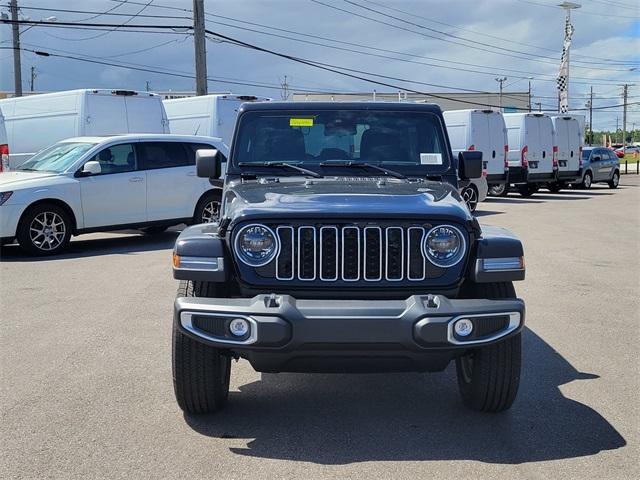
[456,282,522,412]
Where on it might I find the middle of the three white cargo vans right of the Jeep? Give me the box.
[503,113,557,196]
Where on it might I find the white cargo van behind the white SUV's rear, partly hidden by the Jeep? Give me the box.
[164,94,270,145]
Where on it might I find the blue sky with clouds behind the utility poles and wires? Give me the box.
[0,0,640,129]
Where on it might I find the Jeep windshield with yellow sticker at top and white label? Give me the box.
[233,109,450,174]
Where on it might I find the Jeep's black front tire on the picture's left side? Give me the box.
[173,280,231,414]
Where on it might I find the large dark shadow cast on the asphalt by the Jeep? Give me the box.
[185,330,626,465]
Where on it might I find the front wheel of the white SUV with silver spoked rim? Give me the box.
[16,203,72,256]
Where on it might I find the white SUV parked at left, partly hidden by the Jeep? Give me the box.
[0,135,228,255]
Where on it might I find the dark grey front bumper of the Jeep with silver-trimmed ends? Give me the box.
[174,295,525,372]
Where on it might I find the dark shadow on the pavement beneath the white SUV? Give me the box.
[0,230,180,262]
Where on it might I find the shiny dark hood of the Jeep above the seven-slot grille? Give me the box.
[224,177,474,223]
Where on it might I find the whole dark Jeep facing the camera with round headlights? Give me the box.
[173,102,525,413]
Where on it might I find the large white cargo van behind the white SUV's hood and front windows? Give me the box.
[0,90,169,168]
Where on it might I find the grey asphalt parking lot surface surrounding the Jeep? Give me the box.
[0,175,640,479]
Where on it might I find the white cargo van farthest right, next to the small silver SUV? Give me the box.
[548,115,584,192]
